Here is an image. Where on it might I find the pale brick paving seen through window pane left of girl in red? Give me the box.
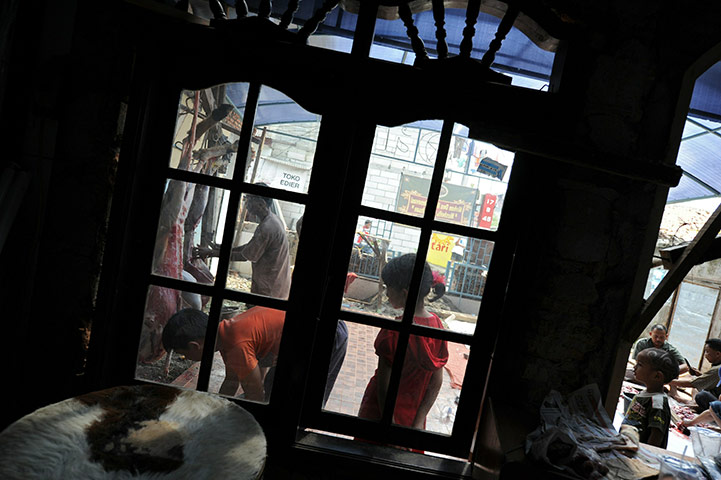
[324,321,380,416]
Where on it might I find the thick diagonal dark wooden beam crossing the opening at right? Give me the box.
[627,205,721,340]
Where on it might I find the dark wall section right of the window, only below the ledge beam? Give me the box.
[490,158,665,404]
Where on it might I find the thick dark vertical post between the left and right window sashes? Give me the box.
[291,115,375,426]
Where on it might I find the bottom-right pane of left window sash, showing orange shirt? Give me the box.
[209,301,285,403]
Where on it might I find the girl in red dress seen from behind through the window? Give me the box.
[358,254,448,429]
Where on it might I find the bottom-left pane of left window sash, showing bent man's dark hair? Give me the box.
[135,285,211,388]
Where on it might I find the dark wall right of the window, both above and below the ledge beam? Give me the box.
[490,2,720,410]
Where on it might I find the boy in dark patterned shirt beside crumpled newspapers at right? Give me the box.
[623,348,679,448]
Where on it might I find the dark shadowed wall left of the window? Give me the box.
[0,2,132,425]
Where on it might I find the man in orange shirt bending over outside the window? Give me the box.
[163,307,285,401]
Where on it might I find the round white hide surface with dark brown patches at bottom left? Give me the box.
[0,385,266,480]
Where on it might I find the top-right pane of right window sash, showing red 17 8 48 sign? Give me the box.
[436,124,514,230]
